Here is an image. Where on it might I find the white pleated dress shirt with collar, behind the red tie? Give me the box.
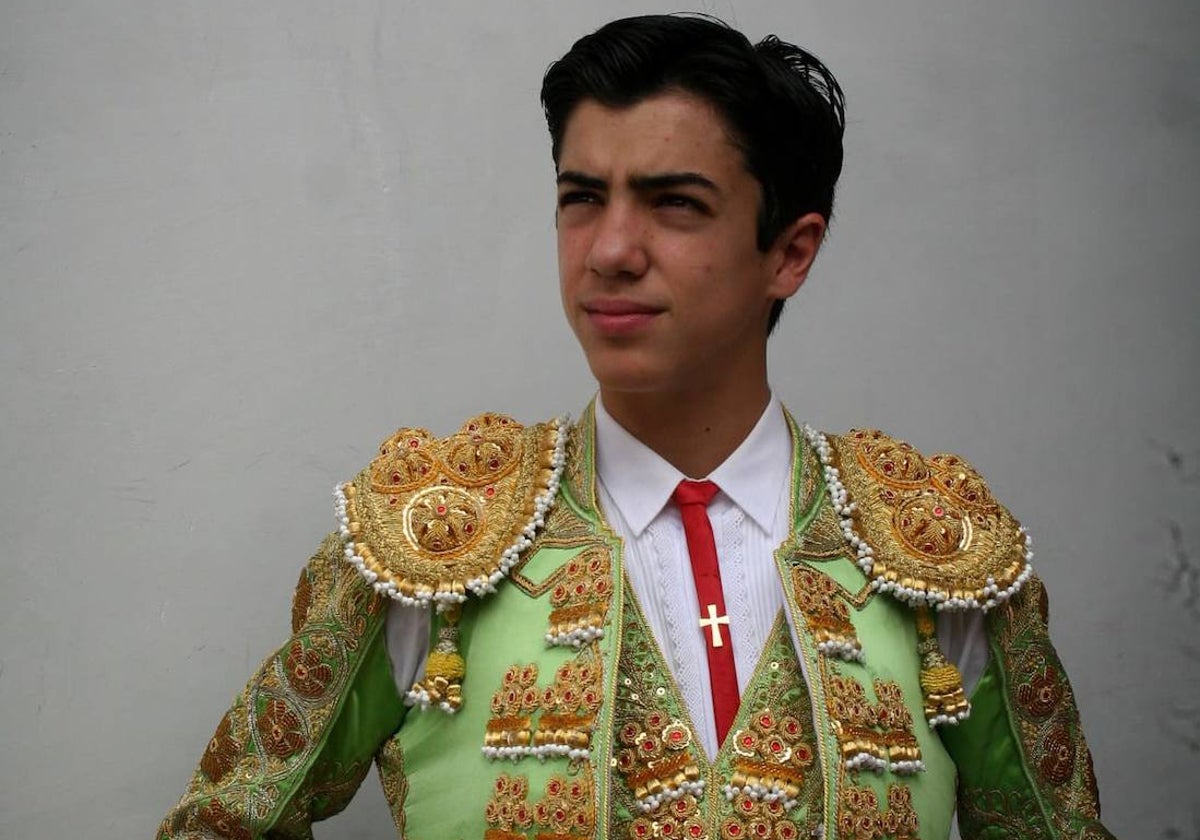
[595,395,792,757]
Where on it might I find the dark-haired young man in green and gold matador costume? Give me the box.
[160,17,1108,840]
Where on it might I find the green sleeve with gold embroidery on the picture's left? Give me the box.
[157,535,403,840]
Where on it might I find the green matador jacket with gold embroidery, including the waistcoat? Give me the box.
[158,412,1109,840]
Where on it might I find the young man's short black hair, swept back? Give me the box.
[541,14,846,331]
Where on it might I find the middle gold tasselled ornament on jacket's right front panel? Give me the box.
[826,668,925,775]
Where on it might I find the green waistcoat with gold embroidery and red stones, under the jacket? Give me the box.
[611,584,822,840]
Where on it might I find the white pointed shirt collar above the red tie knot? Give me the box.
[595,394,792,536]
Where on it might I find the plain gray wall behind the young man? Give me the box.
[0,0,1200,838]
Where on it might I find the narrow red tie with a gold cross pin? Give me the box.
[671,480,742,744]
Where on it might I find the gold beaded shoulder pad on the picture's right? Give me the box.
[805,430,1033,611]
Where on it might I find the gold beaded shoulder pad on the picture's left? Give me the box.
[334,414,568,608]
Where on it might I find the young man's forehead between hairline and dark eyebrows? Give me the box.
[558,92,744,180]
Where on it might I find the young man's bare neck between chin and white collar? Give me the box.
[600,378,770,479]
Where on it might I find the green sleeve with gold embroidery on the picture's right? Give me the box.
[941,576,1112,840]
